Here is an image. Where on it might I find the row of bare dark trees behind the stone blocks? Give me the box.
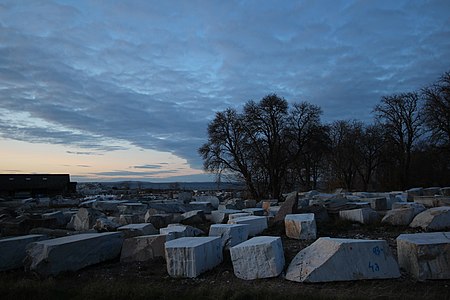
[199,72,450,199]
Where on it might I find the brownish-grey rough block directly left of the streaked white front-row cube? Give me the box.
[120,234,167,262]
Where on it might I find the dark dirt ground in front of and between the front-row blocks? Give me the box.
[0,222,450,300]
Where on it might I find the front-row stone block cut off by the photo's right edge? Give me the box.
[397,232,450,280]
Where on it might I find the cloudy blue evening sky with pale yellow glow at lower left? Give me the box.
[0,0,450,182]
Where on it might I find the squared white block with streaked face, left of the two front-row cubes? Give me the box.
[165,236,223,278]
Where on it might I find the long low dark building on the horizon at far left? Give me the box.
[0,174,77,198]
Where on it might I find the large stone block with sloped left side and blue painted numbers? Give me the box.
[286,238,400,282]
